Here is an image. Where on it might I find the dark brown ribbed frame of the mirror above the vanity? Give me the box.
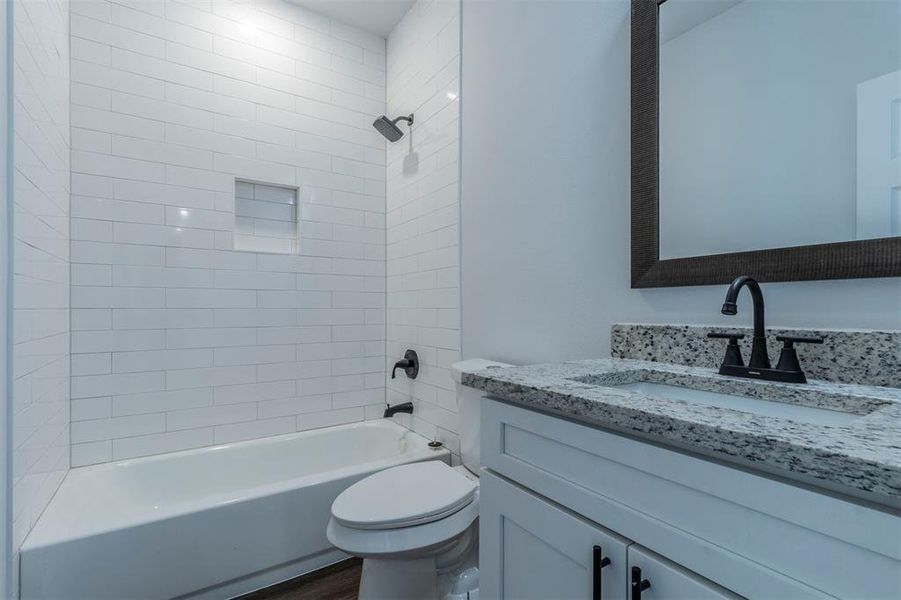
[632,0,901,288]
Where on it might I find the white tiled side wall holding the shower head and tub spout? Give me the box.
[387,0,460,454]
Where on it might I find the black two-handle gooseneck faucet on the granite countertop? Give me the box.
[707,275,823,383]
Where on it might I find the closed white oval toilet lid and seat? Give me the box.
[332,460,478,529]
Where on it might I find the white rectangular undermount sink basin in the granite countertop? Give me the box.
[608,381,861,425]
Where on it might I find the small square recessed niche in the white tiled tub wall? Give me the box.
[234,179,298,254]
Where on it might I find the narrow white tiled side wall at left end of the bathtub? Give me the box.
[12,0,69,576]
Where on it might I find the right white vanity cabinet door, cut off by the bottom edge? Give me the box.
[628,544,741,600]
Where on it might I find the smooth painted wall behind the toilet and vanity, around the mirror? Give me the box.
[461,0,901,363]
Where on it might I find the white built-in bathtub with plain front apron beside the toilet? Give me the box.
[20,420,449,600]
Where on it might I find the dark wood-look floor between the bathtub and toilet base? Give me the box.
[237,558,363,600]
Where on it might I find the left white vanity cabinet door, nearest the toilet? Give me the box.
[479,471,628,600]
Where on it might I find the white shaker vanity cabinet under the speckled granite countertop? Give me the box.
[480,399,901,600]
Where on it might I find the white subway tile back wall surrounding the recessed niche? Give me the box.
[72,0,386,466]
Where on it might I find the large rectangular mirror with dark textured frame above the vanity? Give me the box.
[632,0,901,287]
